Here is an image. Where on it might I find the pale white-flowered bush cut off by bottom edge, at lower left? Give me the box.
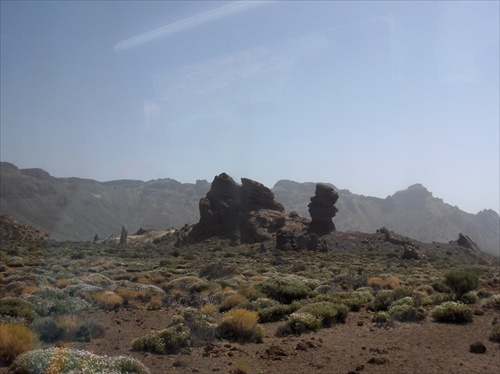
[12,348,150,374]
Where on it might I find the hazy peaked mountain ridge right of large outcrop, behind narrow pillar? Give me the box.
[272,180,500,255]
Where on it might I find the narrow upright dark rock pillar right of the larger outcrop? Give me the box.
[308,184,339,234]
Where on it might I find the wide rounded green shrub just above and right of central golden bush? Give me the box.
[259,278,311,304]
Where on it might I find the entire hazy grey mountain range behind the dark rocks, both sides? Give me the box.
[0,162,500,255]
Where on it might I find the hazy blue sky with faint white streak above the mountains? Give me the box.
[1,1,500,213]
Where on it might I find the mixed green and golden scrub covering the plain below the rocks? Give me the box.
[0,239,500,373]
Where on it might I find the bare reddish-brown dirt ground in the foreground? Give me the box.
[70,309,500,374]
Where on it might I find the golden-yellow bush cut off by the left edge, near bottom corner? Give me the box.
[0,322,38,365]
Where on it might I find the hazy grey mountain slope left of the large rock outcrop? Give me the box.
[0,162,210,240]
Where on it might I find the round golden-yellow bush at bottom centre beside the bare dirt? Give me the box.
[217,309,263,343]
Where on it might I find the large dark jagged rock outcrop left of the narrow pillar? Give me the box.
[189,173,289,244]
